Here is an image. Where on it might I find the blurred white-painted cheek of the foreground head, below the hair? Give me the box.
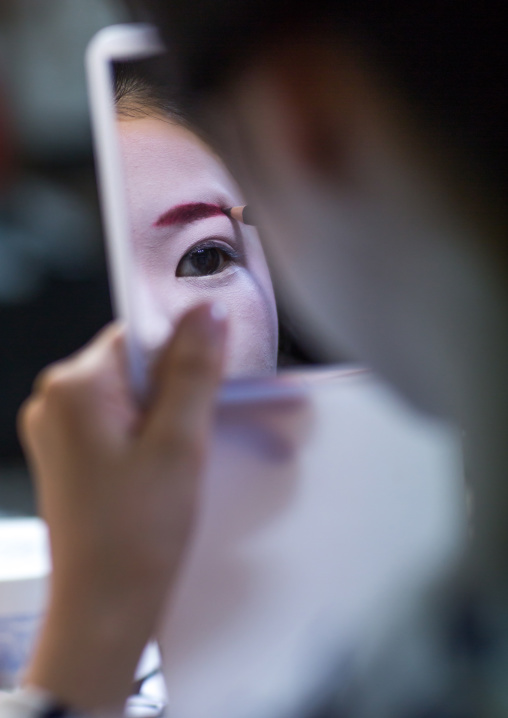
[209,71,506,416]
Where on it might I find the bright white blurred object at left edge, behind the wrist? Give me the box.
[0,518,50,688]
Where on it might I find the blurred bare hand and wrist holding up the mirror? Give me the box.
[19,305,226,710]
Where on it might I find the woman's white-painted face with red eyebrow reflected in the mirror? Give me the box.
[118,117,278,376]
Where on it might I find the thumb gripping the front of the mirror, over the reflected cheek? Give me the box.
[144,304,227,453]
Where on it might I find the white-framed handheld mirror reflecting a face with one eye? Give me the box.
[87,25,298,397]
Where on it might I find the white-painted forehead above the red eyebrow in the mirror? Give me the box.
[118,117,239,209]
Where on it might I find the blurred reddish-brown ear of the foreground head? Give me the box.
[214,37,377,208]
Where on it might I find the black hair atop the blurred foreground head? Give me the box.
[127,0,508,194]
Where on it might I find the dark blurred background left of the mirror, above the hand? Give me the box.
[0,0,127,514]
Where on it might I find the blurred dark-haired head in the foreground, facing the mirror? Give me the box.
[125,0,508,552]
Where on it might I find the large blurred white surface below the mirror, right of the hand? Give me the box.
[160,371,465,718]
